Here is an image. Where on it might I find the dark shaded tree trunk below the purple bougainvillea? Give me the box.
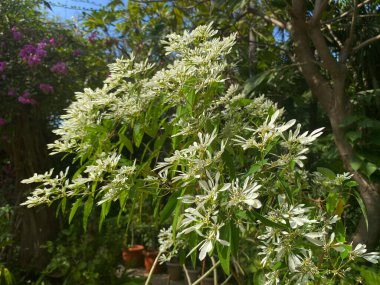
[5,112,58,272]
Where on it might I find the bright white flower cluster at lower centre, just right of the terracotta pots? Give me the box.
[178,171,262,260]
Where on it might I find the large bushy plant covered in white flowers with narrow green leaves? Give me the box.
[23,25,379,284]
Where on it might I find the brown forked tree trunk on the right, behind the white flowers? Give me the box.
[288,0,380,246]
